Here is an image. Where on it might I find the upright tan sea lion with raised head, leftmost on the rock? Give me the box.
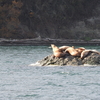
[51,44,66,57]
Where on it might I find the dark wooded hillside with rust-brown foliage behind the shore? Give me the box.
[0,0,100,41]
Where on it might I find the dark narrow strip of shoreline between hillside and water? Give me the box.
[0,38,100,46]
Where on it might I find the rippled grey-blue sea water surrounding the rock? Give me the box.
[0,46,100,100]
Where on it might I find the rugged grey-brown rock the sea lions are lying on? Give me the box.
[38,52,100,66]
